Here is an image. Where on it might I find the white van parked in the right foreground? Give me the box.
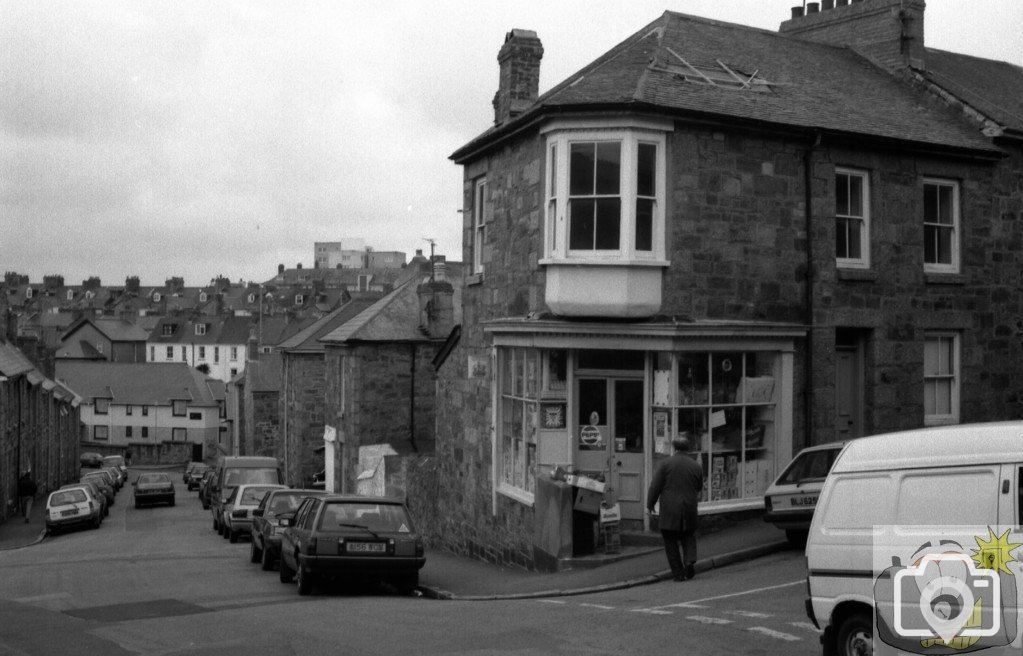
[806,422,1023,656]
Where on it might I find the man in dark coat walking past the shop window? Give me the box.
[647,437,703,581]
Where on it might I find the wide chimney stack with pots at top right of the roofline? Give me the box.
[779,0,926,71]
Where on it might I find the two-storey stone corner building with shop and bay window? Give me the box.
[437,0,1023,567]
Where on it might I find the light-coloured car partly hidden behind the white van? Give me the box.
[764,442,847,546]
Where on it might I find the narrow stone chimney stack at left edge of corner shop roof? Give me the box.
[494,30,543,125]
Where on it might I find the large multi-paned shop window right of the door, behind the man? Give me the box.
[651,352,776,501]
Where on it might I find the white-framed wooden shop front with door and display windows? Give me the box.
[487,319,805,552]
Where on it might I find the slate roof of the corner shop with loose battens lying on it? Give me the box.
[451,11,1000,162]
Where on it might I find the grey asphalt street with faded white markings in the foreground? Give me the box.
[0,470,820,655]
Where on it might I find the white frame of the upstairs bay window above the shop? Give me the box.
[540,119,674,266]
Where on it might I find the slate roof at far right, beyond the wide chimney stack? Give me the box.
[920,48,1023,132]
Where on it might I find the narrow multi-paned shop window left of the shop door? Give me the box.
[497,349,541,502]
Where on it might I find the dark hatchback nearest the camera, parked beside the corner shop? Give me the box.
[280,495,427,595]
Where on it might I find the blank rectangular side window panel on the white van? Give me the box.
[895,469,998,526]
